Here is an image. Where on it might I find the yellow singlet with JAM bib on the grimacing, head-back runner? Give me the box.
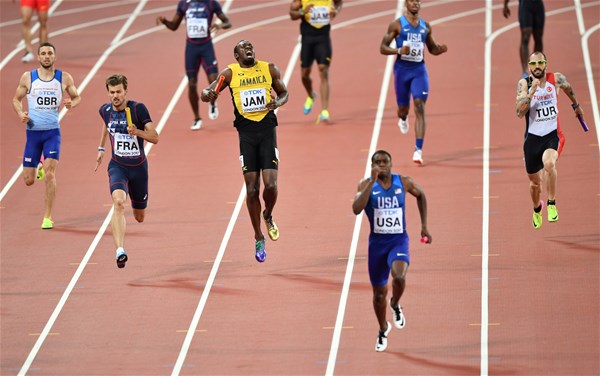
[228,60,273,122]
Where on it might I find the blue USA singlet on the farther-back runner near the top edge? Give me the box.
[396,16,427,66]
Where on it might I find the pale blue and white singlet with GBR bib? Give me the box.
[27,69,62,131]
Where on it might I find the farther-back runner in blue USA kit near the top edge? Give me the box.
[379,0,448,165]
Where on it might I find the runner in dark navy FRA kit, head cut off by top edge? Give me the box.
[156,0,231,131]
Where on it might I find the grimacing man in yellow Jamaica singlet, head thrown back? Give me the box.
[201,40,288,262]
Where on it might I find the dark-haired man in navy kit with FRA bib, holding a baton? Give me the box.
[96,74,158,268]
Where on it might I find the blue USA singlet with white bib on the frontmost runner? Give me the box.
[365,174,407,243]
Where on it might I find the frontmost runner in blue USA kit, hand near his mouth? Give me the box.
[352,150,431,351]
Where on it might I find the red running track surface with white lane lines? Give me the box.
[0,0,600,375]
